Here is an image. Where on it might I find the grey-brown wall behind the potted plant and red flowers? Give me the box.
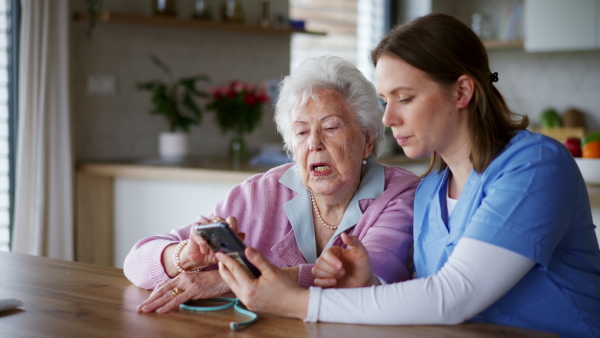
[70,0,290,161]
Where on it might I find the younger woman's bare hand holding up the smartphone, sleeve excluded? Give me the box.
[216,247,309,319]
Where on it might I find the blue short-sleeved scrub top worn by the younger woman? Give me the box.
[414,131,600,337]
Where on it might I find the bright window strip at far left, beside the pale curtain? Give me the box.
[0,0,19,251]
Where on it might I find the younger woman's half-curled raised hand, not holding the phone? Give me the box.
[312,233,379,288]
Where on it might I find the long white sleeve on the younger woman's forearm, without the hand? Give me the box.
[305,238,535,325]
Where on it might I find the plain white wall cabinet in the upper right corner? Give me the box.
[524,0,600,52]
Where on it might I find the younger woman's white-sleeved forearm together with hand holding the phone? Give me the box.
[217,238,534,325]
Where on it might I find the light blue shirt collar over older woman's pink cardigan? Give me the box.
[279,159,385,264]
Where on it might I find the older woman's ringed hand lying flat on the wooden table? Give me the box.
[137,270,229,313]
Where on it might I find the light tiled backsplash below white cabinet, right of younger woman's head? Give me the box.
[490,50,600,130]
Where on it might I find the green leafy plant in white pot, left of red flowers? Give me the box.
[136,55,210,161]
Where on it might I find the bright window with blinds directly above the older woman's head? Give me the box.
[290,0,391,82]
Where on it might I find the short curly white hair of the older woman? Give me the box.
[274,56,384,158]
